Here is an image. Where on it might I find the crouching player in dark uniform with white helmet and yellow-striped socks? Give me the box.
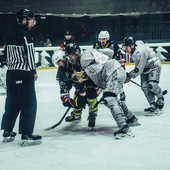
[53,49,98,128]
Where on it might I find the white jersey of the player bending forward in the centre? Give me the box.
[80,48,121,88]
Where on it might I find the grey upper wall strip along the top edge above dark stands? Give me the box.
[0,0,170,17]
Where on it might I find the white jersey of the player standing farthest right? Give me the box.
[129,41,161,78]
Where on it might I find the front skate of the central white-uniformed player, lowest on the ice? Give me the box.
[114,125,135,139]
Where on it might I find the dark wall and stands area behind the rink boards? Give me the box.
[0,13,170,60]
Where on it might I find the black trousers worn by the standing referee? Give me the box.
[1,70,37,134]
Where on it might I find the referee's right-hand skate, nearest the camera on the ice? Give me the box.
[21,135,42,146]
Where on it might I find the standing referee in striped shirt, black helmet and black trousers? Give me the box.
[1,9,41,146]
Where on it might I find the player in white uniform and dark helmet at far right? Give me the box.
[123,37,164,115]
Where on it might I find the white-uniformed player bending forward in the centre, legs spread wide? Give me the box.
[65,45,138,139]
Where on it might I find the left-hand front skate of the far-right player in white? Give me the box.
[144,103,160,116]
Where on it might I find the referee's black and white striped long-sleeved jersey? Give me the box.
[5,27,36,74]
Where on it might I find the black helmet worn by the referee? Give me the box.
[16,9,34,23]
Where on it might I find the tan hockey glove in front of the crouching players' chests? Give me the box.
[72,71,89,83]
